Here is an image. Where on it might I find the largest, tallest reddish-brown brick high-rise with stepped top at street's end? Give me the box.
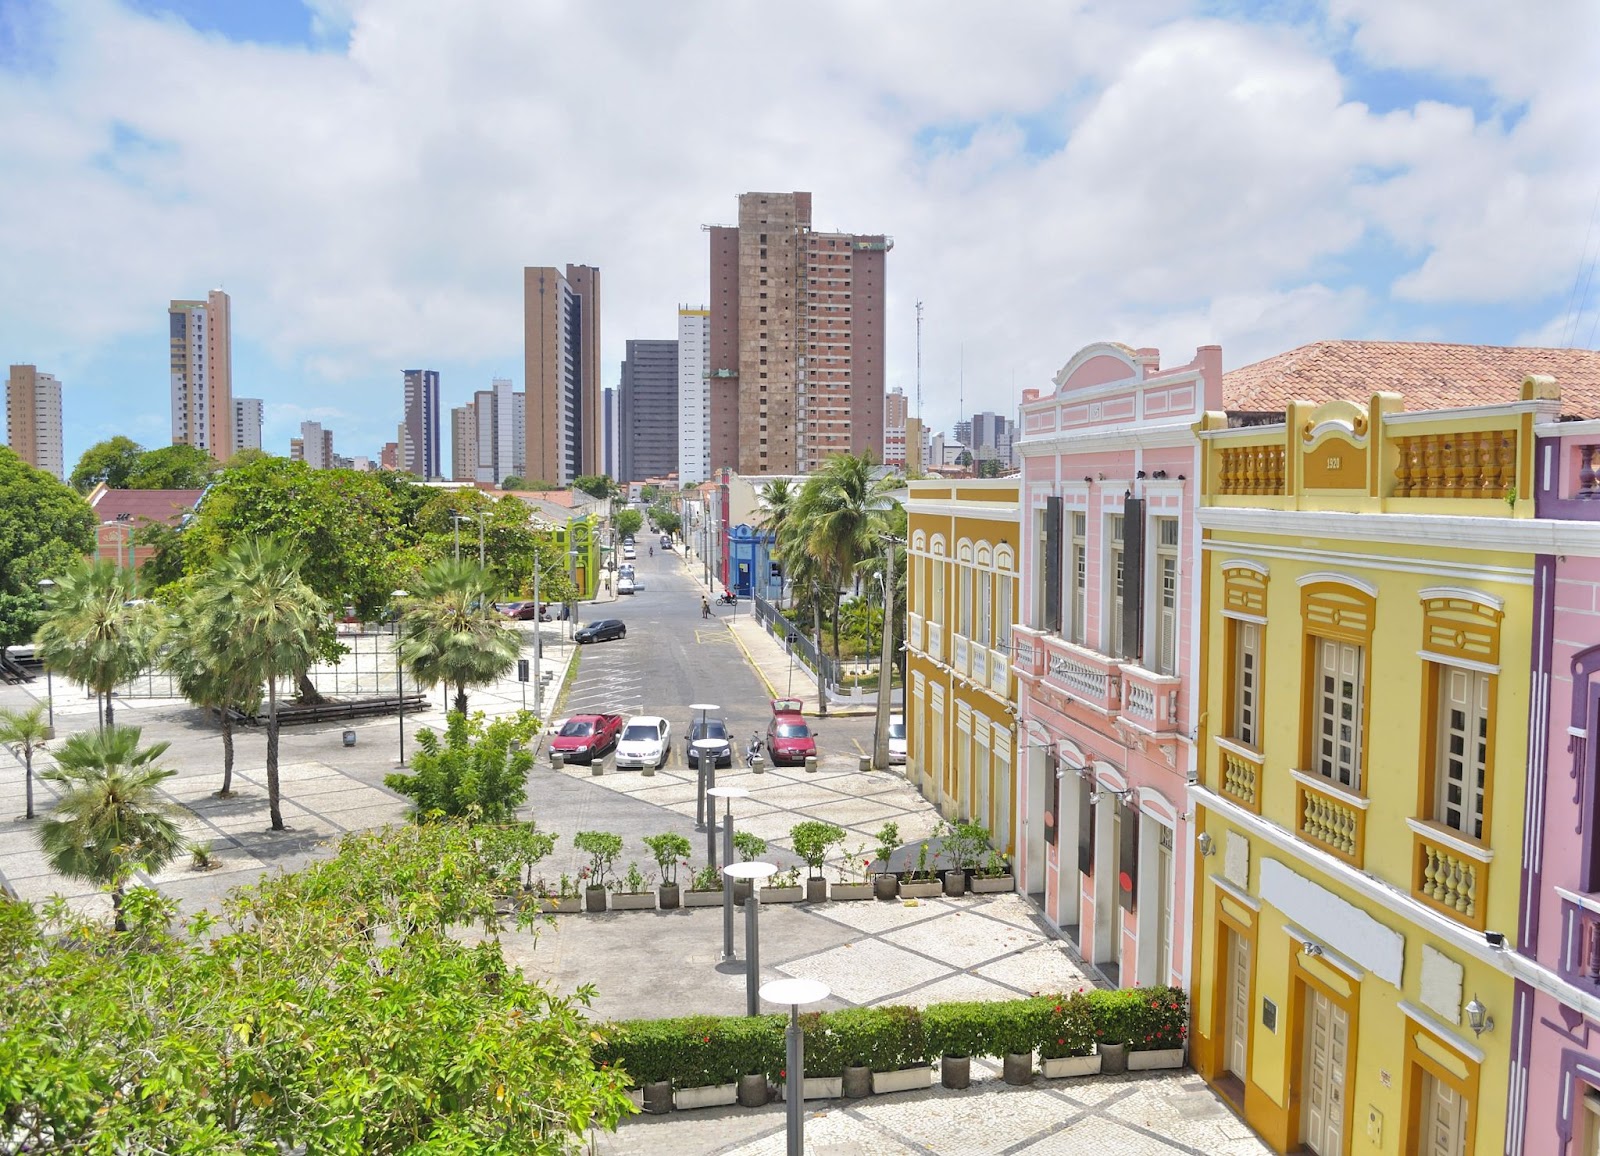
[709,192,894,474]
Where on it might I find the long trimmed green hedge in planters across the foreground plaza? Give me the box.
[595,988,1189,1087]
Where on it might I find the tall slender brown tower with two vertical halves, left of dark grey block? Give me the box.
[522,264,605,485]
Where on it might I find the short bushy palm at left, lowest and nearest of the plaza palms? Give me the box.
[38,727,184,932]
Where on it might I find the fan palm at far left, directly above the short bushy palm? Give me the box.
[34,559,155,727]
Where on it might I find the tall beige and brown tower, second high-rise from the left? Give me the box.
[166,290,234,461]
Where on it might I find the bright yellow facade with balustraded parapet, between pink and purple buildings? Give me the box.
[1190,384,1552,1156]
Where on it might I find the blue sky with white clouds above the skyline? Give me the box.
[0,0,1600,468]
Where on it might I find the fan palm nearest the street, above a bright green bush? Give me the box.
[400,559,522,714]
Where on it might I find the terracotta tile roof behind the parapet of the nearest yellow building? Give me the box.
[1222,341,1600,418]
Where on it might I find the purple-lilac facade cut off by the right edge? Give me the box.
[1506,421,1600,1156]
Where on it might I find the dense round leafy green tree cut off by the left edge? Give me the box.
[0,445,94,647]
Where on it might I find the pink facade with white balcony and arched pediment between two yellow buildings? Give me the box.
[1013,343,1224,986]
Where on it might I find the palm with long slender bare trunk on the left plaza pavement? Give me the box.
[190,538,328,831]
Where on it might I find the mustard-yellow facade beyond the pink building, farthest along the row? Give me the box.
[906,479,1021,858]
